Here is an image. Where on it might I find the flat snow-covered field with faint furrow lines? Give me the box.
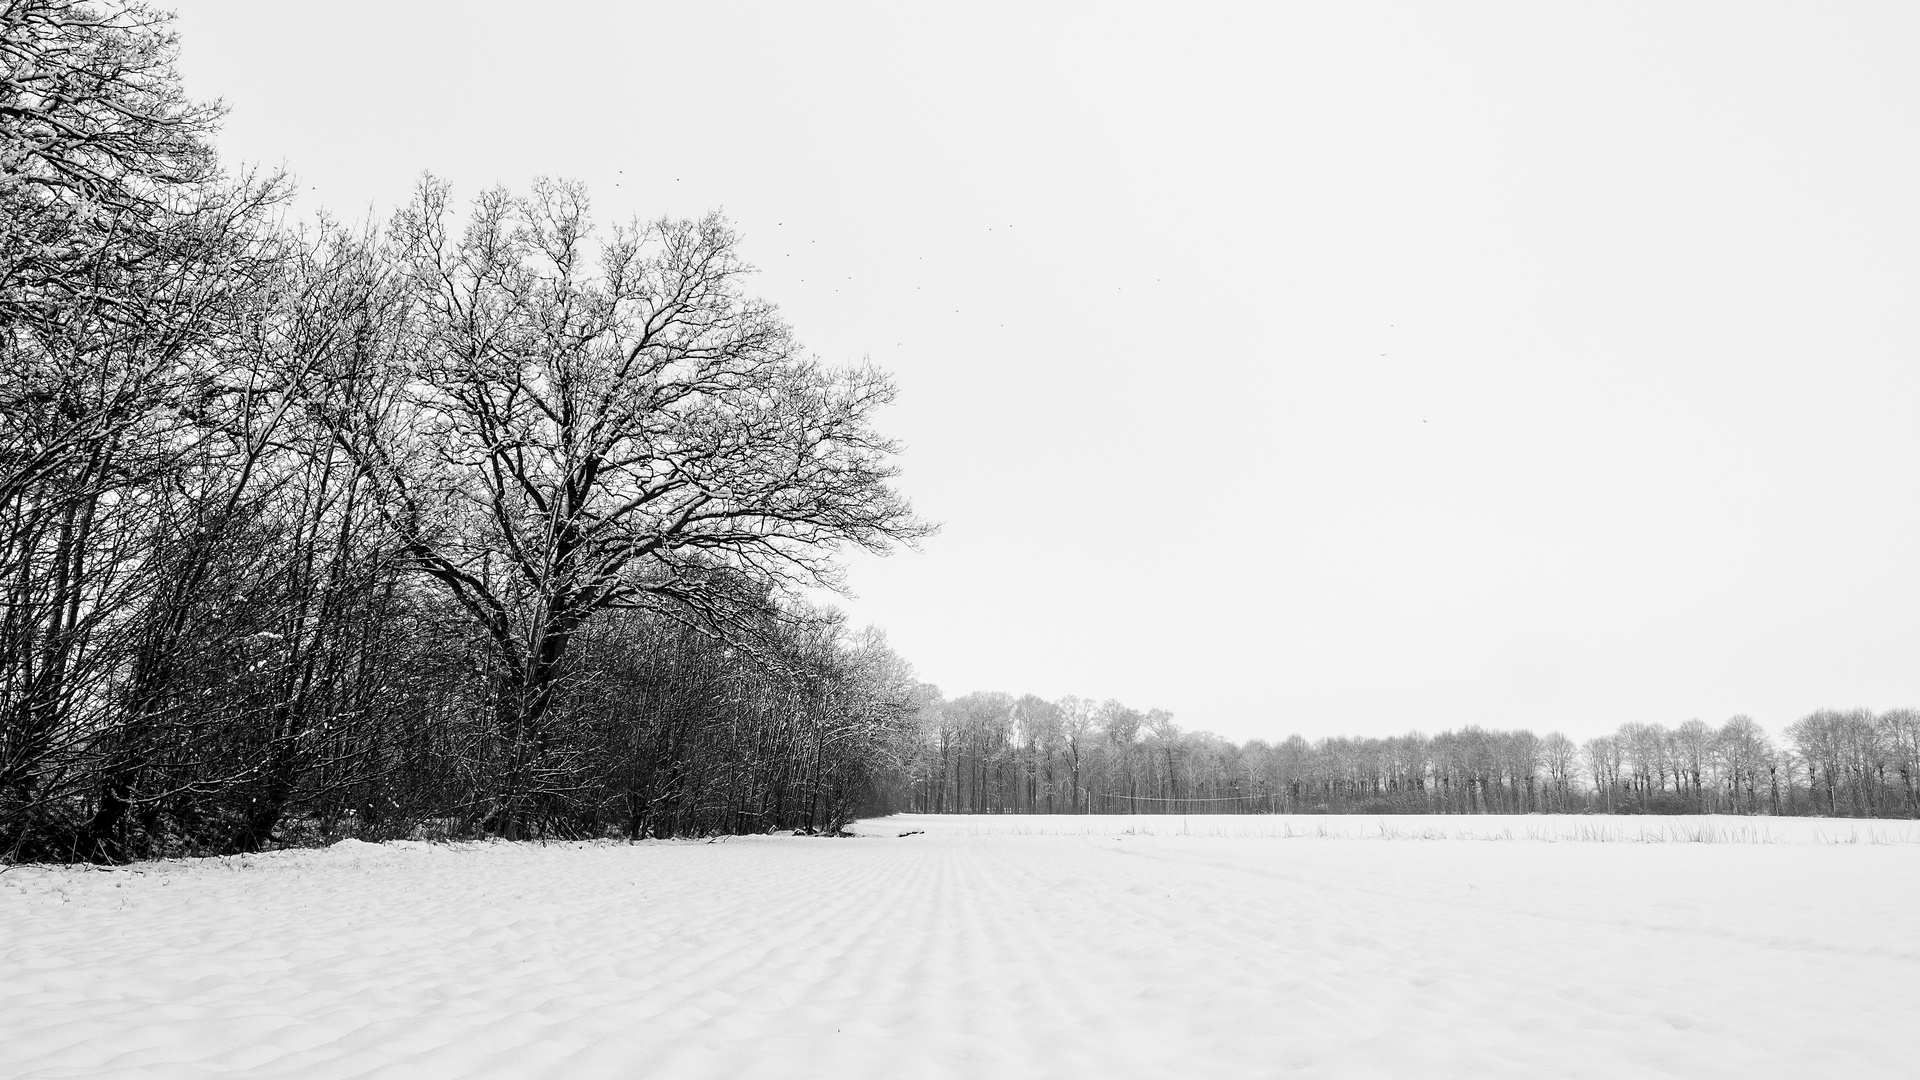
[0,817,1920,1080]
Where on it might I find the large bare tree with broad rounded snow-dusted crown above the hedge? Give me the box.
[324,181,925,836]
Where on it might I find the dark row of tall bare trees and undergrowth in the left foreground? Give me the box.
[0,0,925,859]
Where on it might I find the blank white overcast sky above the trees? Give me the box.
[169,0,1920,738]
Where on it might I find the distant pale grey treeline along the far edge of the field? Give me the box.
[889,690,1920,817]
